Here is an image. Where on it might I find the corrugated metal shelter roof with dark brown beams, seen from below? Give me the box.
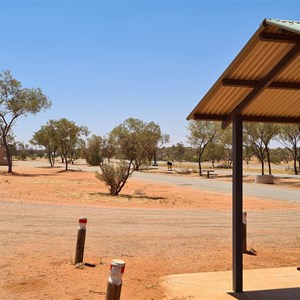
[187,19,300,127]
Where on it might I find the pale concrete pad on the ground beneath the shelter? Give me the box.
[162,267,300,300]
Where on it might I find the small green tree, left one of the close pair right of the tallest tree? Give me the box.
[30,120,59,167]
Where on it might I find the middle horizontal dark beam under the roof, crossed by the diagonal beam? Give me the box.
[222,78,300,90]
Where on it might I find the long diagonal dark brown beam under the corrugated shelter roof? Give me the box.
[222,43,300,129]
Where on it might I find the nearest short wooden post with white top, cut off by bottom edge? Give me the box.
[105,259,125,300]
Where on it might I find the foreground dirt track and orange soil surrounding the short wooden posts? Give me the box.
[0,202,300,299]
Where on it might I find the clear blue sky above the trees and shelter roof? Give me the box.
[0,0,300,144]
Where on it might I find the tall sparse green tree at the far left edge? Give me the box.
[0,71,51,173]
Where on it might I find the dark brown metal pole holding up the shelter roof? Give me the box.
[232,114,243,293]
